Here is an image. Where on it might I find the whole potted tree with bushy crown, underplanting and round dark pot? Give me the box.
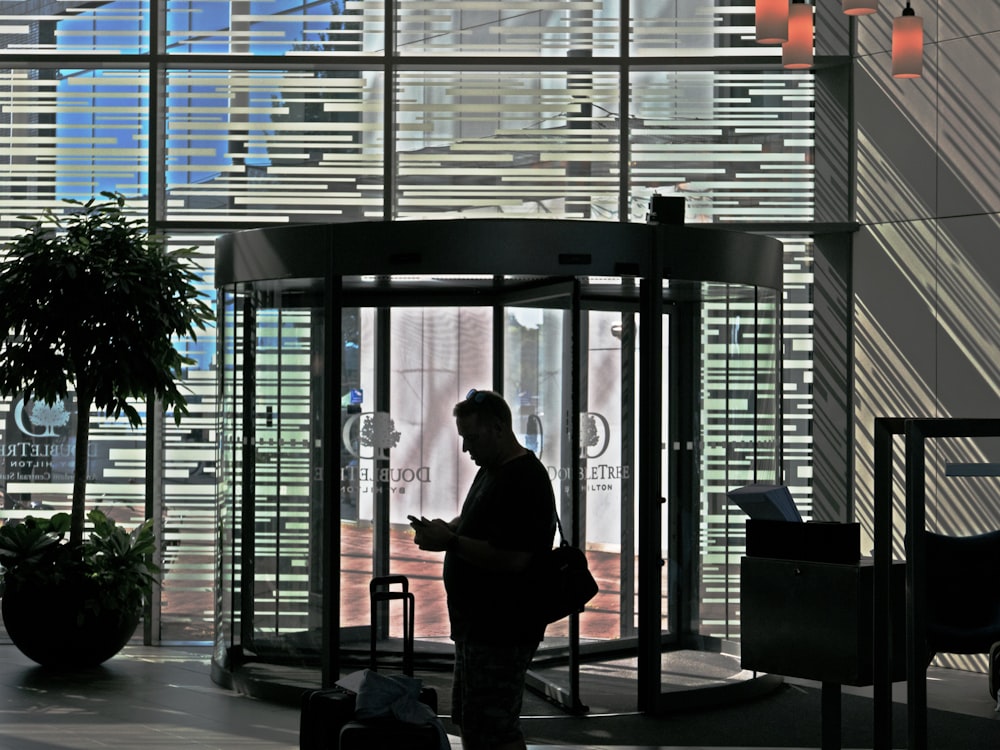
[0,192,212,666]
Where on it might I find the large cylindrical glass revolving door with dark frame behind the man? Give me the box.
[213,220,781,711]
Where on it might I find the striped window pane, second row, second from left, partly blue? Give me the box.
[166,70,384,222]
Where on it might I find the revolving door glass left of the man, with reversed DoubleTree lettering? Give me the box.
[341,307,493,648]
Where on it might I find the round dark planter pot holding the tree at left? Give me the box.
[0,582,141,669]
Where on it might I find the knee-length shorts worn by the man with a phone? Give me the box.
[451,640,538,748]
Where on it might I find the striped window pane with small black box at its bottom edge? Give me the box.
[629,70,815,223]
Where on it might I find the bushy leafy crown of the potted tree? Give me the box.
[0,192,213,540]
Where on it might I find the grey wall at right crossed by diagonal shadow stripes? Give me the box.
[852,0,1000,588]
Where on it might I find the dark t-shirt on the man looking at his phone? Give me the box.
[444,452,556,643]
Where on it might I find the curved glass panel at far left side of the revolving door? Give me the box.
[238,292,323,659]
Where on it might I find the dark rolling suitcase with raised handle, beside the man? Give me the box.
[340,575,448,750]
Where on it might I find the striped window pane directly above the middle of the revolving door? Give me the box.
[396,71,619,219]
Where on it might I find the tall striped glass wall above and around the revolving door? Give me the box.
[0,0,824,642]
